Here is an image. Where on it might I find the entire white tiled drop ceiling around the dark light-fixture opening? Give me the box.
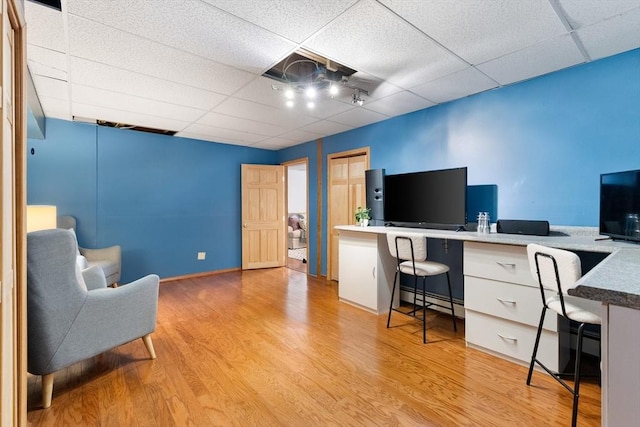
[25,0,640,150]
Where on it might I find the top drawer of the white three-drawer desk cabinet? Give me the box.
[463,242,538,287]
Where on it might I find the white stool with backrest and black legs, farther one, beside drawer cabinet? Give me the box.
[387,232,458,343]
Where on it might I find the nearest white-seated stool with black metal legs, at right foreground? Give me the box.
[527,243,601,426]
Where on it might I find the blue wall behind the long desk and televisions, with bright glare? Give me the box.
[322,49,640,274]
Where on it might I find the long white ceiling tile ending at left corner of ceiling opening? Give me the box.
[69,17,255,95]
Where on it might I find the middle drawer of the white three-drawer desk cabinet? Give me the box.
[464,276,558,332]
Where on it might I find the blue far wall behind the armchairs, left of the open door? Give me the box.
[27,120,276,283]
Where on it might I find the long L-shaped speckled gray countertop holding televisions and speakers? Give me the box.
[336,224,640,310]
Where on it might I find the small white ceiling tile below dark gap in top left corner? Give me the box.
[24,1,67,53]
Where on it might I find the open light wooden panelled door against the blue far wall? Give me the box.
[242,165,286,270]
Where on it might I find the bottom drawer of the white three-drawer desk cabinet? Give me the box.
[465,310,558,370]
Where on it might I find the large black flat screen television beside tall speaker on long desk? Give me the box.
[384,167,467,230]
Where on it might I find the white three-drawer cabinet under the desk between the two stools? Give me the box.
[464,242,558,370]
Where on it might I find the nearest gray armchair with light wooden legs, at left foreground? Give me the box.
[27,229,159,408]
